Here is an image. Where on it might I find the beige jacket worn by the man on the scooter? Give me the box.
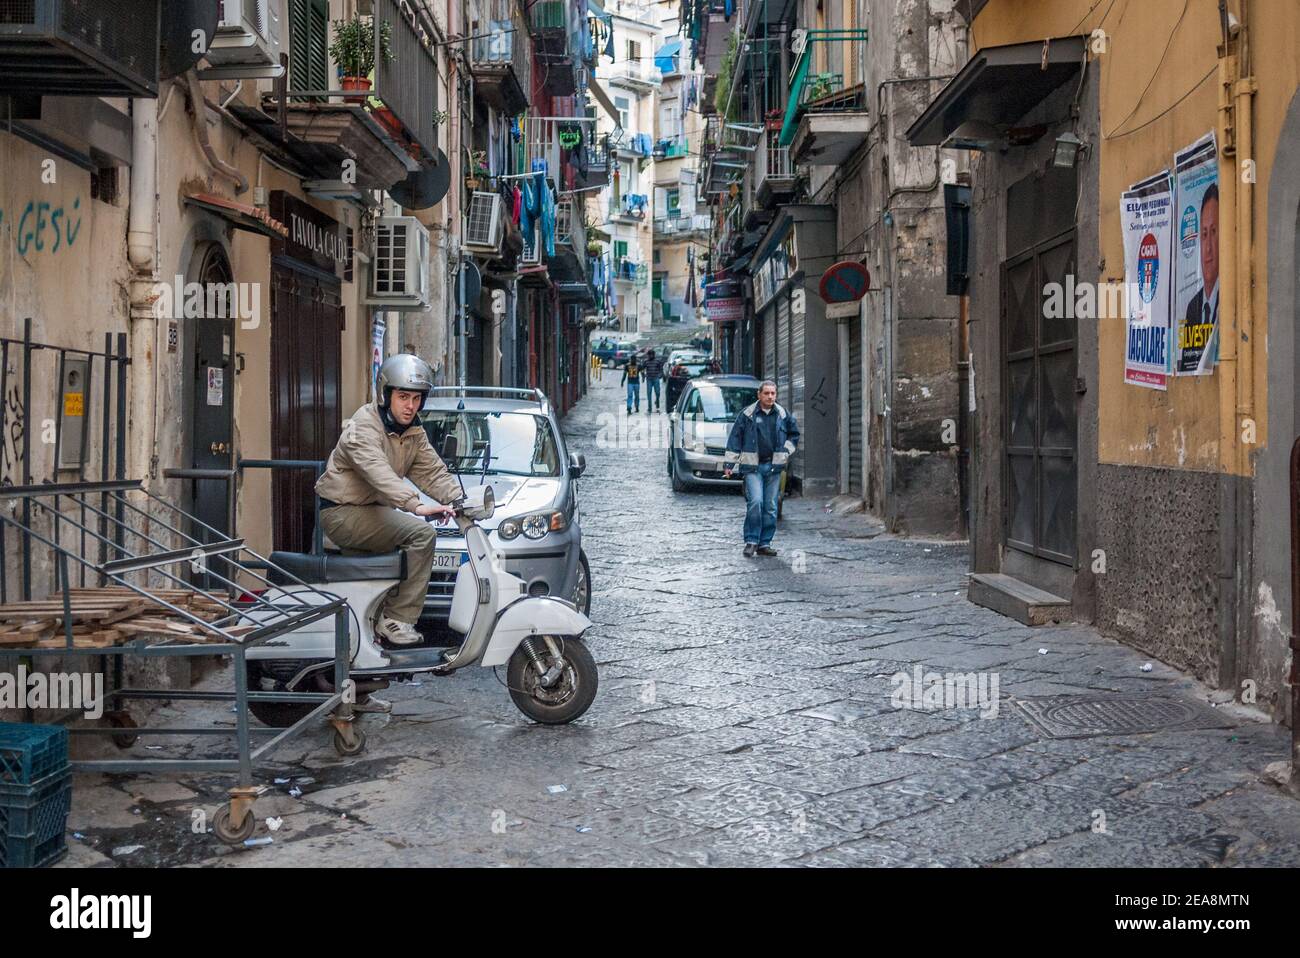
[316,403,460,512]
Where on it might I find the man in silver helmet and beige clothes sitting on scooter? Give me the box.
[316,354,462,646]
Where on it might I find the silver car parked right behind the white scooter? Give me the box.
[417,386,592,636]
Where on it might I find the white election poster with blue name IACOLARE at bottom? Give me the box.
[1119,170,1174,389]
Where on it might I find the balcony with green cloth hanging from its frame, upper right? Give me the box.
[780,30,870,166]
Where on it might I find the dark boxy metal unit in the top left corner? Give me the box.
[0,0,161,97]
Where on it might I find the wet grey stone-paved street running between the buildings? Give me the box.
[65,370,1300,866]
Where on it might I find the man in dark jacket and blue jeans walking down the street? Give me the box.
[723,380,800,559]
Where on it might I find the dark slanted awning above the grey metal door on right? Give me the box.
[907,36,1087,149]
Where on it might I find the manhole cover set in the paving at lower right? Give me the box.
[1015,694,1232,738]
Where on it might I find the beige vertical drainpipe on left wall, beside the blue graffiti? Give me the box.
[126,99,159,480]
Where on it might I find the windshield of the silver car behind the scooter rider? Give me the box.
[420,409,560,477]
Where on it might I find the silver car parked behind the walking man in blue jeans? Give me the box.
[668,374,759,493]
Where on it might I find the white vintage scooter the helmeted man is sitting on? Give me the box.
[248,437,598,754]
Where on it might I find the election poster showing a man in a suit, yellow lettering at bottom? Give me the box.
[1174,131,1219,376]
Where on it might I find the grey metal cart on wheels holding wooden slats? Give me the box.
[0,480,365,844]
